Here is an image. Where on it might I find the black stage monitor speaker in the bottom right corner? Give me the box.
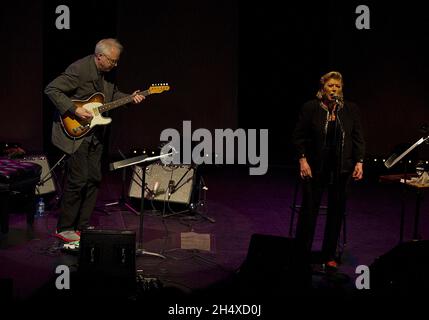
[370,240,429,293]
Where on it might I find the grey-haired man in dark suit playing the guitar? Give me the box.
[45,39,145,242]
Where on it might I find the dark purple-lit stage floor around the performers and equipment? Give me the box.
[0,166,429,308]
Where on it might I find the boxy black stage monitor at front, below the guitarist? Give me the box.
[78,230,136,281]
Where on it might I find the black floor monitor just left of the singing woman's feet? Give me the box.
[239,234,312,292]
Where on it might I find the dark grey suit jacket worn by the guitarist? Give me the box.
[45,55,127,154]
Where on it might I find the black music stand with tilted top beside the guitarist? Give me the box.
[110,152,173,259]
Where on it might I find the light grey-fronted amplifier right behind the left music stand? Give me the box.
[128,162,195,204]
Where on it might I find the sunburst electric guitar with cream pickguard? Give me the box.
[61,83,170,139]
